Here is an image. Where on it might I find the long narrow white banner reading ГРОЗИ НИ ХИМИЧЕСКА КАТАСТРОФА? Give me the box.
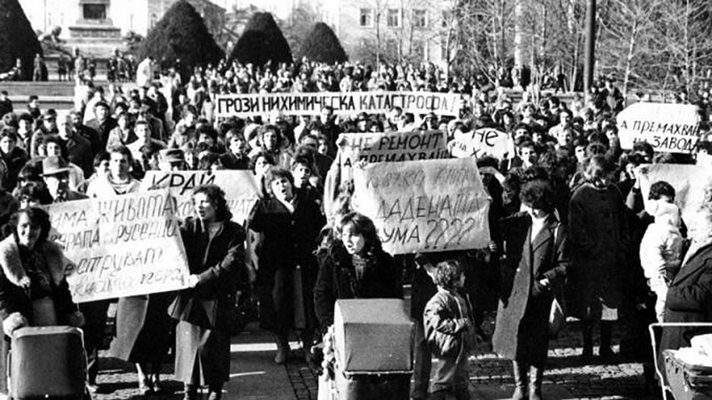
[215,92,461,118]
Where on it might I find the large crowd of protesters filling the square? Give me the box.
[0,59,712,400]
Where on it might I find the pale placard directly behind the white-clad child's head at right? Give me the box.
[637,164,712,227]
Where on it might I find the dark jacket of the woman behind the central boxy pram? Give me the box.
[314,241,403,329]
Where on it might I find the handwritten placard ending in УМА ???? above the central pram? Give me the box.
[354,158,490,254]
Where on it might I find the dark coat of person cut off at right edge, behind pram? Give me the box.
[660,244,712,365]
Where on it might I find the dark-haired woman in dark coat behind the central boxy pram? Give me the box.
[314,212,403,331]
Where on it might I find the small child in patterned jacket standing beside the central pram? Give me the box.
[423,260,475,400]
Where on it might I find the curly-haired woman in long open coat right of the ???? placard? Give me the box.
[492,180,568,400]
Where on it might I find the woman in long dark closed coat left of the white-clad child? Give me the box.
[567,155,630,359]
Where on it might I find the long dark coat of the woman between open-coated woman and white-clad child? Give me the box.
[567,183,629,318]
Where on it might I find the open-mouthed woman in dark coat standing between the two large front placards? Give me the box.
[249,167,326,364]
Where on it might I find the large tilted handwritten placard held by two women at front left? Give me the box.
[45,190,190,303]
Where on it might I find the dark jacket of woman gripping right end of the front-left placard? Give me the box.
[169,217,245,330]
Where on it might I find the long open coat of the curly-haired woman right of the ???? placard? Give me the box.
[492,213,569,364]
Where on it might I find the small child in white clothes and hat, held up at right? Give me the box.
[640,201,683,322]
